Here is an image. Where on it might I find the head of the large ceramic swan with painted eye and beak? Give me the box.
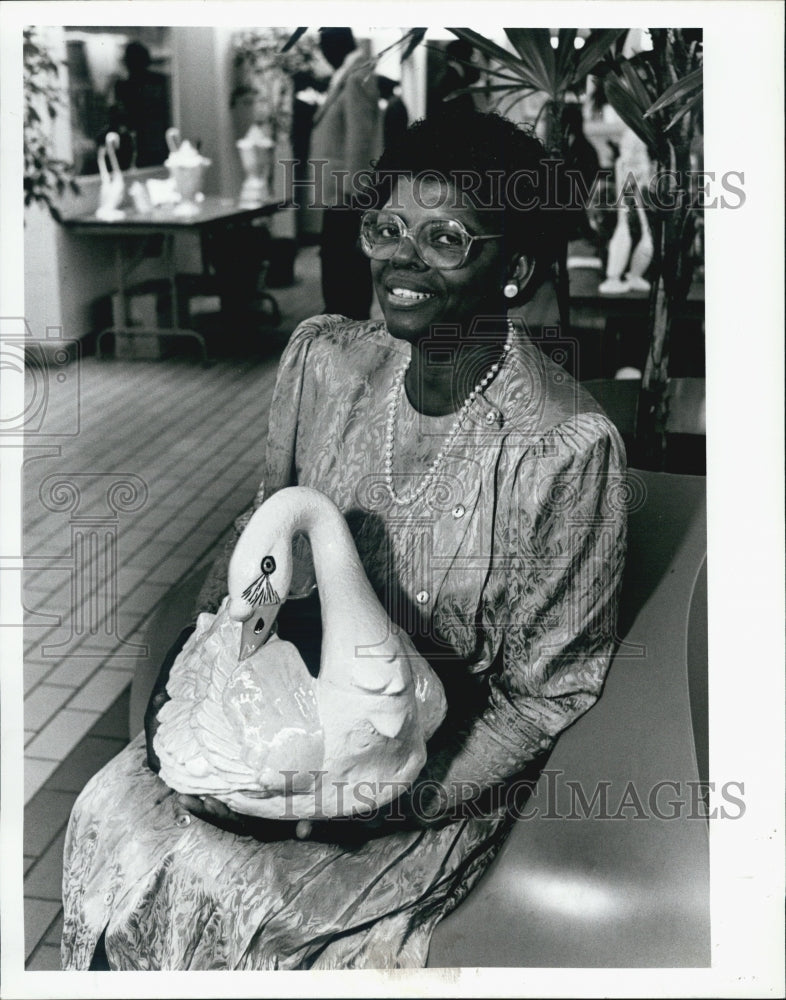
[227,504,292,659]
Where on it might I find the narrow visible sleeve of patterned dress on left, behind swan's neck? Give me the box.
[193,317,320,620]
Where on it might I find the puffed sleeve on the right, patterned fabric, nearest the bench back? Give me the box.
[411,414,626,819]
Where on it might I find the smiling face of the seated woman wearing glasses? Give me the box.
[371,177,506,342]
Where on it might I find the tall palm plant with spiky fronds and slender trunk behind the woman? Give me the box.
[426,28,703,469]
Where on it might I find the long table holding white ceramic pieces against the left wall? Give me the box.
[63,197,282,364]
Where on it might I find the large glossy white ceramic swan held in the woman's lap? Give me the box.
[154,487,446,819]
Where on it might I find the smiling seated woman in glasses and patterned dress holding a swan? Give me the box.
[63,114,625,969]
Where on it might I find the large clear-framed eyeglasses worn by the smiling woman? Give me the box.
[360,210,502,271]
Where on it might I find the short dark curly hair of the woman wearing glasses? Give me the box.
[374,109,565,291]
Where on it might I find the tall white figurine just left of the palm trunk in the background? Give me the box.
[598,129,653,295]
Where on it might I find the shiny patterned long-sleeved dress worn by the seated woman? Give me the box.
[62,316,625,970]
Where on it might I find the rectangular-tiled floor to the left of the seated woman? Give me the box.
[24,242,320,970]
